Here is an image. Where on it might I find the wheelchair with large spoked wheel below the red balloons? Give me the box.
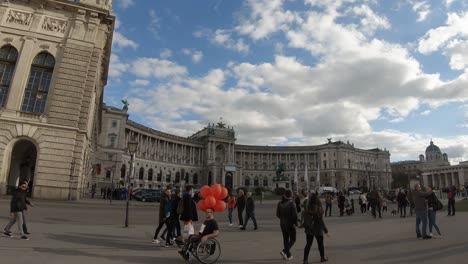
[183,238,221,264]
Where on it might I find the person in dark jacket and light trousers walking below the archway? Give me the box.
[3,181,32,240]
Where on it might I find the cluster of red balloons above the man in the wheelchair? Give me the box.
[197,184,228,212]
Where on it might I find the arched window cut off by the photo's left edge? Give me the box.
[0,46,18,108]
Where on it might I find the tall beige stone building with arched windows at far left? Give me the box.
[0,0,115,200]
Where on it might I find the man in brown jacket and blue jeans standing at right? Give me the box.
[412,183,432,239]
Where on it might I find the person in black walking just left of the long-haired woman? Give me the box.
[276,190,297,260]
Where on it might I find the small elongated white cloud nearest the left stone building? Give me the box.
[130,58,187,78]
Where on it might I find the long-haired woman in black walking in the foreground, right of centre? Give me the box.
[303,193,328,264]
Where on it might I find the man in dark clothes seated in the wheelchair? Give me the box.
[179,208,219,260]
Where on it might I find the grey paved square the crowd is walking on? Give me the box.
[0,197,468,264]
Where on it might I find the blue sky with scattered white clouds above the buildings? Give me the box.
[104,0,468,164]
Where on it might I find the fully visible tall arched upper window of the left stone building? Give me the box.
[21,52,55,113]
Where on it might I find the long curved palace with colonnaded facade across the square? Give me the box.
[97,106,391,193]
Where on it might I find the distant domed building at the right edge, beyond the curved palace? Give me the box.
[392,140,468,188]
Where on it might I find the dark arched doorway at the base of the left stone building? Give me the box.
[7,140,37,195]
